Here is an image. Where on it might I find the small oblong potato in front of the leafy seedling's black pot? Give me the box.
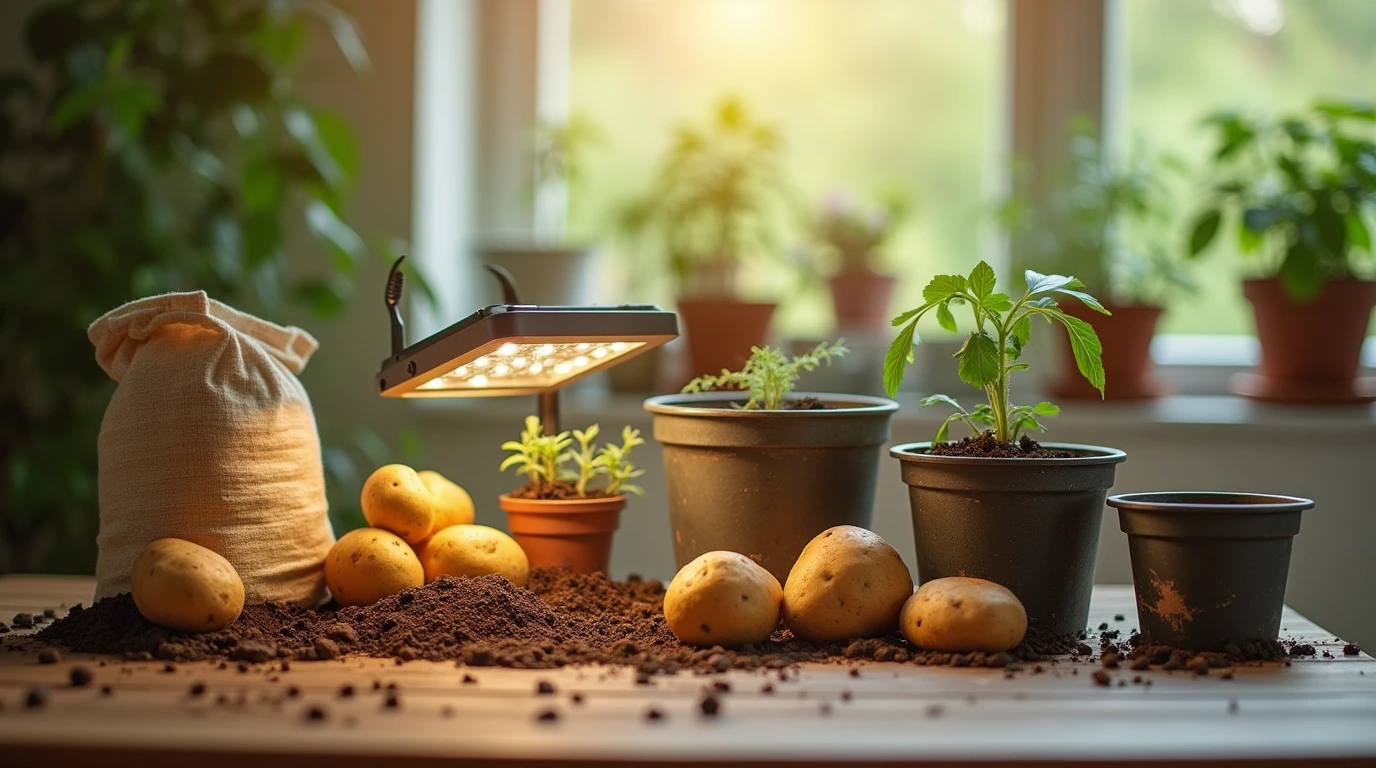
[899,577,1028,654]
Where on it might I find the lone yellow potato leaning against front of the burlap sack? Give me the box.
[129,538,244,632]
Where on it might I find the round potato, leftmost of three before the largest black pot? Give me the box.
[665,551,783,647]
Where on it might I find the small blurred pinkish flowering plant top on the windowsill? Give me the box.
[812,187,912,274]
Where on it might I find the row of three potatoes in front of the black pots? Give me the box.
[665,526,1026,652]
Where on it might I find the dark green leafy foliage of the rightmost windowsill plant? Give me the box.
[1189,100,1376,301]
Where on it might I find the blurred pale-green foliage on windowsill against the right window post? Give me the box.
[998,120,1196,307]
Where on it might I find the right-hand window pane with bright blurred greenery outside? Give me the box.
[1123,0,1376,333]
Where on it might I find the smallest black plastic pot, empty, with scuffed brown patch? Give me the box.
[1109,491,1314,651]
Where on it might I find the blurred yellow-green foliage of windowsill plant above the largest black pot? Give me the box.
[619,96,791,296]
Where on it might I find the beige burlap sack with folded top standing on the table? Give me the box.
[88,292,334,604]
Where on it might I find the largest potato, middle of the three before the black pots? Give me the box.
[783,526,912,643]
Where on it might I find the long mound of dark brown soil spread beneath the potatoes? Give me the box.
[39,568,1075,674]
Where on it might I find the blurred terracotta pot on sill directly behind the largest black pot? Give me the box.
[678,299,777,378]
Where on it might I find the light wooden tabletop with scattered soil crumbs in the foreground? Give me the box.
[0,577,1376,768]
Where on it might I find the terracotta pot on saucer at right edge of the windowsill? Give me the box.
[1233,279,1376,403]
